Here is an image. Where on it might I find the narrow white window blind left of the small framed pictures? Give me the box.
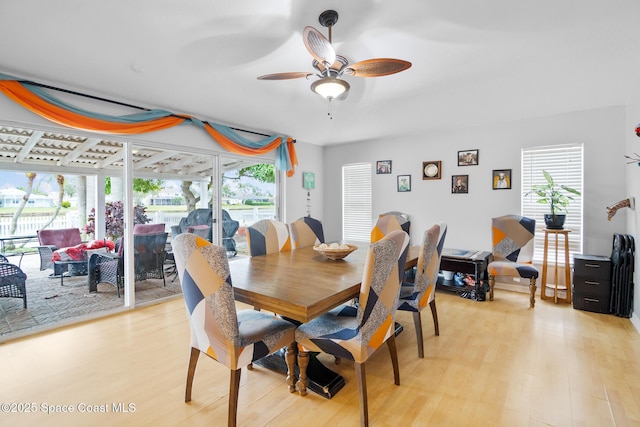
[342,163,372,242]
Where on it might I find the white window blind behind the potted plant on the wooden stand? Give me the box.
[522,144,583,263]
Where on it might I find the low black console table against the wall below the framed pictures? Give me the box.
[437,248,492,301]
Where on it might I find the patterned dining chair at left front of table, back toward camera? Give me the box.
[172,233,295,426]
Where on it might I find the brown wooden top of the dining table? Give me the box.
[229,242,420,398]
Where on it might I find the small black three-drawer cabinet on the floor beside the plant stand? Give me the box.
[573,255,611,313]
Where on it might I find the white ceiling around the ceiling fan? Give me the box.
[0,0,640,145]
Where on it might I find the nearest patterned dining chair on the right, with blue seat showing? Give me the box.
[296,230,409,426]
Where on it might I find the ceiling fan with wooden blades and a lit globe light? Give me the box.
[258,10,411,101]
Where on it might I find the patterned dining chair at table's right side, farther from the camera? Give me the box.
[398,223,447,358]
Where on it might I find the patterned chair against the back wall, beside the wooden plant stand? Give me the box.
[487,215,538,308]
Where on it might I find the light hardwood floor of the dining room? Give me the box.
[0,290,640,427]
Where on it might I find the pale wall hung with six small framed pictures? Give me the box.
[324,106,628,255]
